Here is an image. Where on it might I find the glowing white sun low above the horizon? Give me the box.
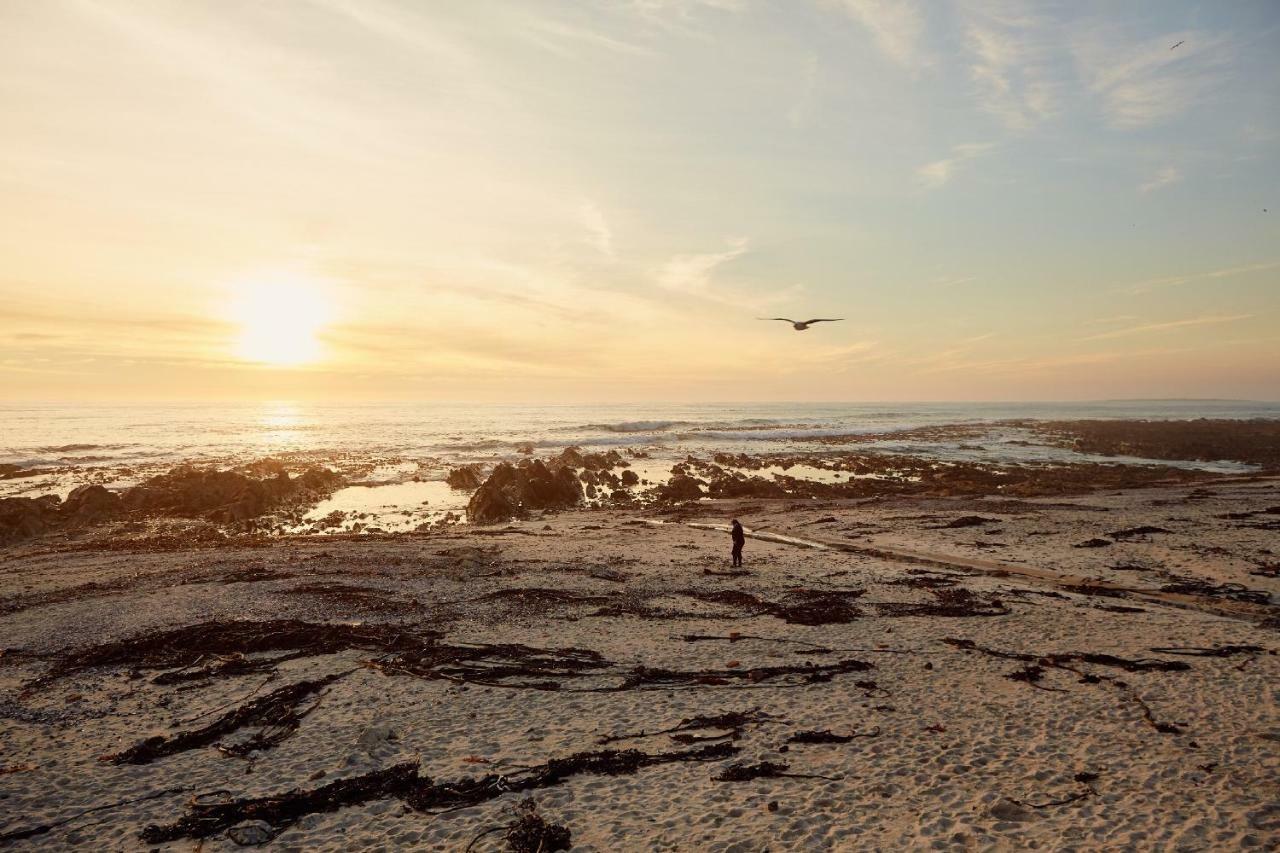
[232,274,332,366]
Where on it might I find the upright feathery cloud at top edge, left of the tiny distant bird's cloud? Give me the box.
[963,0,1059,131]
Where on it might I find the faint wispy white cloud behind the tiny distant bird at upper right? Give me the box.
[1073,28,1234,129]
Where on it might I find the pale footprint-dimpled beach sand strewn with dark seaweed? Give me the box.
[0,478,1280,852]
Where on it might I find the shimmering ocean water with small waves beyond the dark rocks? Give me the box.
[0,401,1280,529]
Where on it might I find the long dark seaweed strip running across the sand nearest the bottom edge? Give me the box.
[142,743,737,844]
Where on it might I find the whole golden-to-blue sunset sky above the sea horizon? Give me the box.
[0,0,1280,402]
